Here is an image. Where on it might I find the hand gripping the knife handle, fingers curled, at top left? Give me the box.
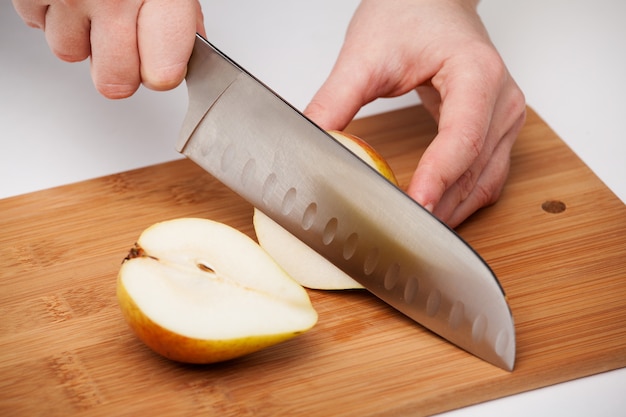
[13,0,204,99]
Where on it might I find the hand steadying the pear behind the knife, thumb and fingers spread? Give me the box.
[305,0,526,227]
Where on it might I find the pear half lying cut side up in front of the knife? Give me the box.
[117,218,317,363]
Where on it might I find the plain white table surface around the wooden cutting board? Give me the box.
[0,0,626,416]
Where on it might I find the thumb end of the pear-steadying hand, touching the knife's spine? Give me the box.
[304,60,371,130]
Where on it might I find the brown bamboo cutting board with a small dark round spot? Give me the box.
[0,106,626,417]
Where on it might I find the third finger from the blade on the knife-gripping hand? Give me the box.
[45,3,91,62]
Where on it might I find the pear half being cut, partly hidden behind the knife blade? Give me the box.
[253,131,398,290]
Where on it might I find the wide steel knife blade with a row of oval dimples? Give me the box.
[176,35,516,371]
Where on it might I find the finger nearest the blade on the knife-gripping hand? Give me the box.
[137,0,199,90]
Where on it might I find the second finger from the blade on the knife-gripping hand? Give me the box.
[90,2,141,99]
